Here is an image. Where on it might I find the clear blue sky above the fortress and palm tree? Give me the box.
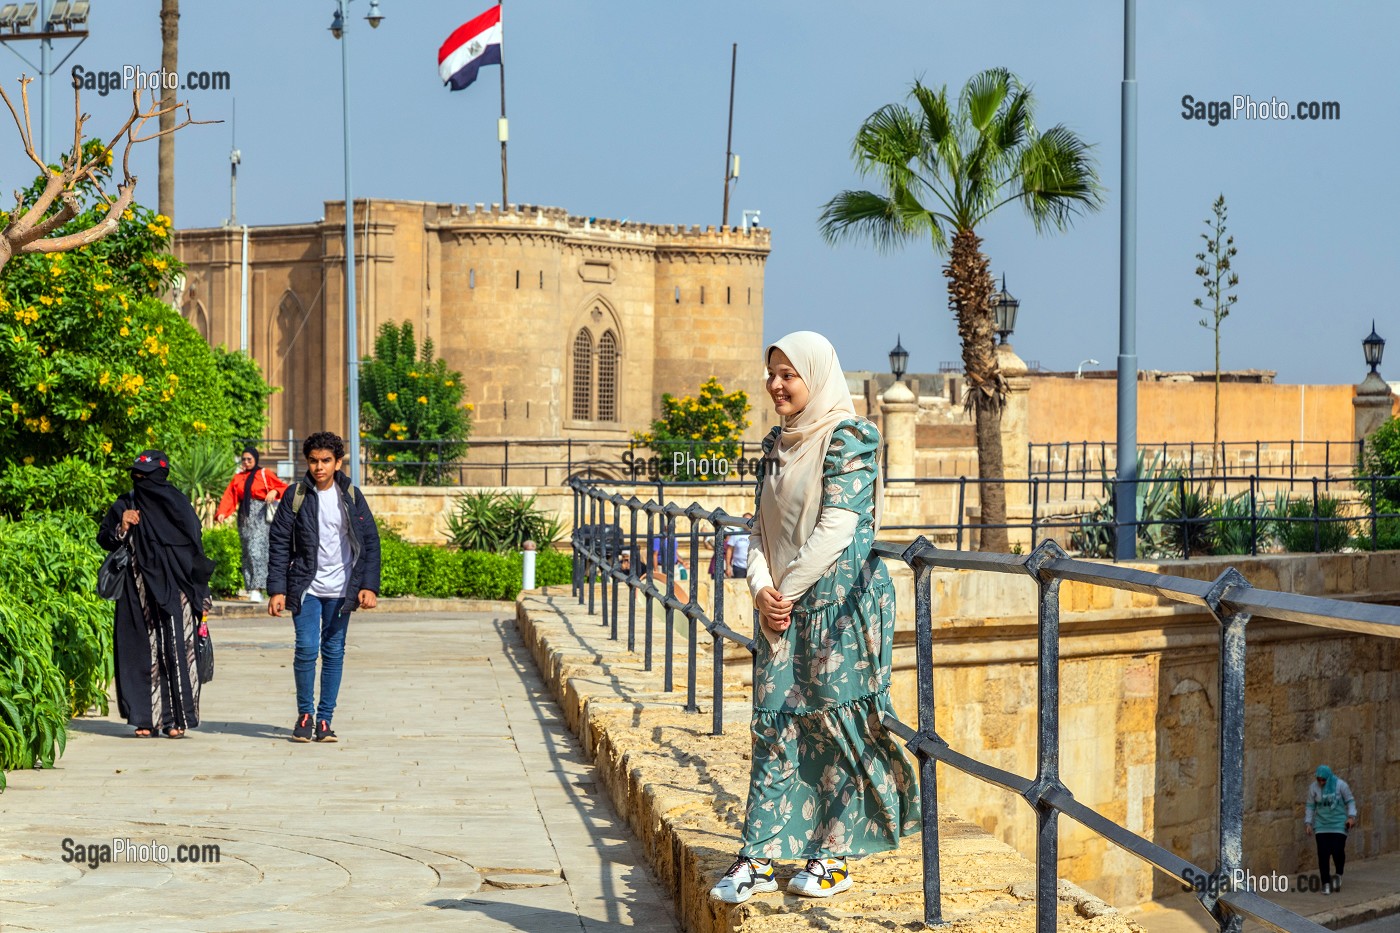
[0,0,1400,382]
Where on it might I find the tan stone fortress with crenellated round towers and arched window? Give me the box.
[175,199,773,453]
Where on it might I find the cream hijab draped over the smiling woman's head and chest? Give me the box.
[757,331,882,591]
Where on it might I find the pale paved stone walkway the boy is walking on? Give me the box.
[0,609,676,933]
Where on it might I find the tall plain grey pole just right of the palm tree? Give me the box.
[1113,0,1138,560]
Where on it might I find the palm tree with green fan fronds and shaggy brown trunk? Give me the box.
[820,69,1103,552]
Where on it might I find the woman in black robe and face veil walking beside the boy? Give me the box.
[97,450,214,738]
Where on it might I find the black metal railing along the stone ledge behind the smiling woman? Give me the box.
[570,481,1400,933]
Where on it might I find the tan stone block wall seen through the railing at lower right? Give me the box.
[711,552,1400,906]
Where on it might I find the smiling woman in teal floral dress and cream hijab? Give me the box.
[710,331,920,904]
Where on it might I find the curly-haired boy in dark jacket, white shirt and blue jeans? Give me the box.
[267,431,379,742]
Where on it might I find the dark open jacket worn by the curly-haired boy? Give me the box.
[267,471,379,614]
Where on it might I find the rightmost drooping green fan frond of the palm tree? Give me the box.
[1008,125,1103,233]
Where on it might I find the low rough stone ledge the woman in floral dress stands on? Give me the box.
[517,588,1141,933]
